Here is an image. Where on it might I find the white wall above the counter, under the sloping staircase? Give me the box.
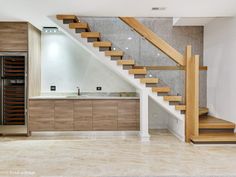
[41,34,136,92]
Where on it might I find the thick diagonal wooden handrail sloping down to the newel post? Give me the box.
[119,17,185,66]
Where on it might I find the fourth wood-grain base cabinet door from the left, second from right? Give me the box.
[93,100,117,131]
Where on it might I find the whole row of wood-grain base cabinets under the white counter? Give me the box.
[29,99,139,131]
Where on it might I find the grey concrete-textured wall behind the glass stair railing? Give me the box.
[80,17,207,106]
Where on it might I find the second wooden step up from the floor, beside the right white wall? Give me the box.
[199,115,235,129]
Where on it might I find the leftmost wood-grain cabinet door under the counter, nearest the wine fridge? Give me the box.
[29,100,54,131]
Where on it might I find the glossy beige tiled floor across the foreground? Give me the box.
[0,131,236,177]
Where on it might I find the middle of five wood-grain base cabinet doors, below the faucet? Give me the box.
[74,100,93,131]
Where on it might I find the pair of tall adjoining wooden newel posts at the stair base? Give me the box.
[185,45,199,142]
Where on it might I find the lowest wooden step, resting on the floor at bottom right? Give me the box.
[191,133,236,143]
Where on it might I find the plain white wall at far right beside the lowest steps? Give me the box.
[204,17,236,123]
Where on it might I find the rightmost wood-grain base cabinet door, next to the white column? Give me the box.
[118,100,138,130]
